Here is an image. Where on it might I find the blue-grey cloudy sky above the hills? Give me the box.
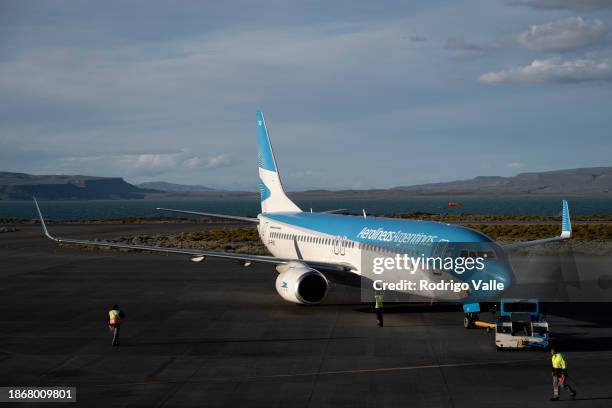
[0,0,612,191]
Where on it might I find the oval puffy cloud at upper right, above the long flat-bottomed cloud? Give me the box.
[516,17,608,52]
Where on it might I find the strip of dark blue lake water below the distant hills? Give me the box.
[0,196,612,220]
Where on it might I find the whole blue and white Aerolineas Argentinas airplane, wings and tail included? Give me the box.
[34,112,572,304]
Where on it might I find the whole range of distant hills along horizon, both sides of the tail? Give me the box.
[0,167,612,200]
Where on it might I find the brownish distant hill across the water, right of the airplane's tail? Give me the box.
[392,167,612,194]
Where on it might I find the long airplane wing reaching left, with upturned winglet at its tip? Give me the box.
[34,198,353,272]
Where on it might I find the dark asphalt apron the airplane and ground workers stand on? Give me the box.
[0,224,612,408]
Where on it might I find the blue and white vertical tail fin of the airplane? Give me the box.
[257,112,302,213]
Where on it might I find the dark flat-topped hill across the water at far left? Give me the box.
[0,172,158,200]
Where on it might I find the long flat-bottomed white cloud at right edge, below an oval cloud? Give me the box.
[479,59,612,85]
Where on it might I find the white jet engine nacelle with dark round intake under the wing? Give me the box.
[276,263,329,305]
